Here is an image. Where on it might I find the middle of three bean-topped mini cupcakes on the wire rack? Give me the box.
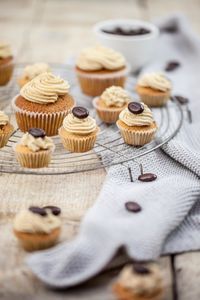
[59,106,99,152]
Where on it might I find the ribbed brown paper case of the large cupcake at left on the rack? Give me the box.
[12,97,69,136]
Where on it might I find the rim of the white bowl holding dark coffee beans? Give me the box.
[93,19,160,41]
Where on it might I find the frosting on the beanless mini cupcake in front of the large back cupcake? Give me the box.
[100,86,131,107]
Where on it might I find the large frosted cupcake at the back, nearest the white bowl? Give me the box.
[76,46,127,96]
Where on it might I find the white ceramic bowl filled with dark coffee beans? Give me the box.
[93,19,159,71]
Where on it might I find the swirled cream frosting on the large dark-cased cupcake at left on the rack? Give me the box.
[20,72,69,104]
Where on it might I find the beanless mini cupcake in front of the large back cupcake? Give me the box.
[93,86,131,123]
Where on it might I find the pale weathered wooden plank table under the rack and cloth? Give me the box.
[0,0,200,300]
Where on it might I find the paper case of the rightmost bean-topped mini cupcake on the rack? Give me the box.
[118,126,157,146]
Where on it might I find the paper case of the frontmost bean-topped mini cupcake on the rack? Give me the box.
[14,147,54,169]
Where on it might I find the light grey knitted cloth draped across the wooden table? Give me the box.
[28,16,200,288]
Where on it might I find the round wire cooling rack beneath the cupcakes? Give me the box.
[0,64,183,175]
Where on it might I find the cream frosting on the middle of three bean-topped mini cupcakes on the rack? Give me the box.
[63,113,97,135]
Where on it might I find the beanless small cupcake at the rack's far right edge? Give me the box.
[136,73,172,107]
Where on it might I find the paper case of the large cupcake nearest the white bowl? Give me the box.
[76,68,128,97]
